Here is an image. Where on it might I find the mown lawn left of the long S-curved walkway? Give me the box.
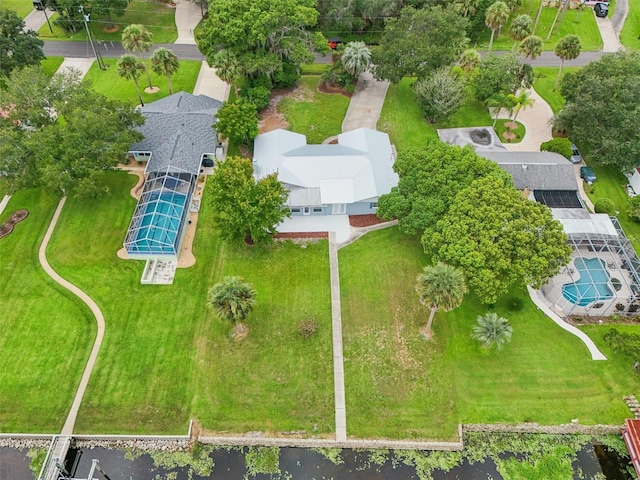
[0,190,95,433]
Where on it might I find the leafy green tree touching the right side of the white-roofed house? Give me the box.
[377,140,511,235]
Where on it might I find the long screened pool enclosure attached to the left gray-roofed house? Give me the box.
[124,170,196,258]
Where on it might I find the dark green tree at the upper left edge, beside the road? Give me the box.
[0,9,44,82]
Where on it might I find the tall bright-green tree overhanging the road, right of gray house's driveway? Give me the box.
[198,0,328,83]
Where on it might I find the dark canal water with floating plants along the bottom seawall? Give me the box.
[0,444,634,480]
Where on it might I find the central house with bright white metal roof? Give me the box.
[253,128,398,215]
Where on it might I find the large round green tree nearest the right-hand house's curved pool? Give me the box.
[430,176,571,303]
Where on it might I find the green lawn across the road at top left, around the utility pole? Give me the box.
[38,0,178,43]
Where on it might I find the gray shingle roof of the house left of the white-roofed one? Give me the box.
[130,92,222,174]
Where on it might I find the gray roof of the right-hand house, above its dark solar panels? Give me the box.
[478,151,578,190]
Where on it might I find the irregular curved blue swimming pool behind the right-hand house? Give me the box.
[562,258,613,307]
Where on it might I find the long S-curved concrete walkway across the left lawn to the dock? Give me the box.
[38,197,105,435]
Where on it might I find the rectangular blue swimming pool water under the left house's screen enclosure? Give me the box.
[135,193,186,254]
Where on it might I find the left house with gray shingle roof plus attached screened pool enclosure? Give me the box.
[124,92,222,261]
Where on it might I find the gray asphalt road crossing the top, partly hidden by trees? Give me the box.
[44,41,604,67]
